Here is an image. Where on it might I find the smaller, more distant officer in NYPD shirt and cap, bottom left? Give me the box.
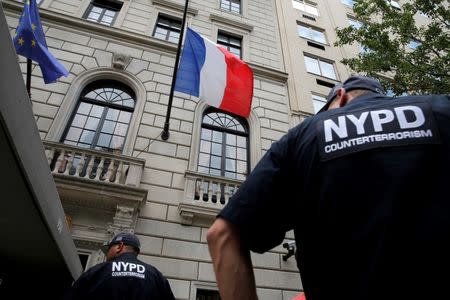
[66,233,175,300]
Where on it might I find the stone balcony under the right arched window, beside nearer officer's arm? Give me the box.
[178,170,243,225]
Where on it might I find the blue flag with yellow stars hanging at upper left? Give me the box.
[14,0,69,83]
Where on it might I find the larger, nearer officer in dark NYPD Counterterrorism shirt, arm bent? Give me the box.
[207,76,450,300]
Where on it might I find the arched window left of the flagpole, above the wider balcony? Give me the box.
[62,80,136,153]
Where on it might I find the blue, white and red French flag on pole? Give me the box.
[175,27,253,117]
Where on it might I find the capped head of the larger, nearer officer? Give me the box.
[319,75,385,113]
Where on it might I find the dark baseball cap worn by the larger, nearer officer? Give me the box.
[319,75,385,113]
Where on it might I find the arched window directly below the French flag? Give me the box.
[198,108,250,180]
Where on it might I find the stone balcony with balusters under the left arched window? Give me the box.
[43,141,147,210]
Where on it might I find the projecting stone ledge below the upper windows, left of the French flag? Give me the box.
[2,0,177,55]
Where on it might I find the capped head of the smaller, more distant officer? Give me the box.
[101,232,141,261]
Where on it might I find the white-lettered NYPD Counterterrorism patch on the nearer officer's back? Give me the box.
[317,102,441,160]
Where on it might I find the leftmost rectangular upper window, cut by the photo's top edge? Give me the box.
[84,0,122,26]
